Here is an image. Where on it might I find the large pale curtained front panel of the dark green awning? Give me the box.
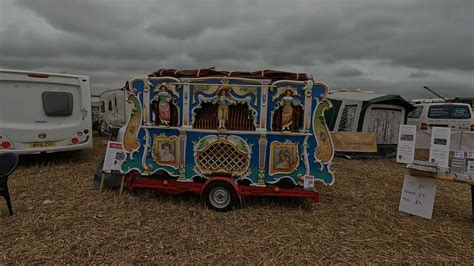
[363,104,405,144]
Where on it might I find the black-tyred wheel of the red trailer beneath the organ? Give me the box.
[203,181,239,212]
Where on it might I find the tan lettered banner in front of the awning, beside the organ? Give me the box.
[331,132,377,152]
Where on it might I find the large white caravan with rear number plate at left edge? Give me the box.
[0,69,92,154]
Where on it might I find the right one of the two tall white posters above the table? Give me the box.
[430,127,451,168]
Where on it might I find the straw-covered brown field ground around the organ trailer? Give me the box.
[0,138,474,264]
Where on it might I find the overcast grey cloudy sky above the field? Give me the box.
[0,0,474,99]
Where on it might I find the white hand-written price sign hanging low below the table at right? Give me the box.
[399,175,437,219]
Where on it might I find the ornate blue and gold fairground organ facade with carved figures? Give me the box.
[122,70,334,186]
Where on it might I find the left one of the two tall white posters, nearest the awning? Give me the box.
[397,125,416,163]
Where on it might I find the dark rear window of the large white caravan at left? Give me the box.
[42,91,73,117]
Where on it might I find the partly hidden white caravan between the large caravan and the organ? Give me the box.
[99,88,131,137]
